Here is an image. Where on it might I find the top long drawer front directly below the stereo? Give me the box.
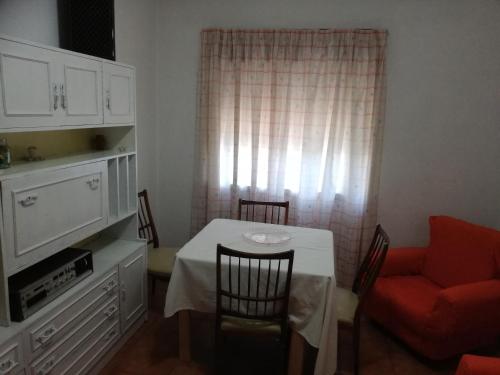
[27,268,118,358]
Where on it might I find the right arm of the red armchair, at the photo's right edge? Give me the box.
[429,279,500,336]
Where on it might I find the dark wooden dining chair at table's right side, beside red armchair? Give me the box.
[336,224,389,375]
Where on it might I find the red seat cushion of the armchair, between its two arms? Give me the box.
[370,275,442,333]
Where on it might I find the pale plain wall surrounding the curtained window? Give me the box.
[156,0,500,245]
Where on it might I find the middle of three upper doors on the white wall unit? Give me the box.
[58,53,103,125]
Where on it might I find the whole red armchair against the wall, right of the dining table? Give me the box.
[365,216,500,359]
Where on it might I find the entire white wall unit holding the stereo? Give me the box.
[0,35,144,375]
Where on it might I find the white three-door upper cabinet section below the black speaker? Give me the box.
[0,37,135,131]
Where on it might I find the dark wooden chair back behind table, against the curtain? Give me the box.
[238,199,290,225]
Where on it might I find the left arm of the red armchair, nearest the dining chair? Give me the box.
[380,247,427,276]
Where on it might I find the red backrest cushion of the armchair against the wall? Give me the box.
[422,216,500,288]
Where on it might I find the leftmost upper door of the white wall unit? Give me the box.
[0,39,60,129]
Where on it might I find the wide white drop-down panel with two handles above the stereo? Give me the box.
[2,162,108,274]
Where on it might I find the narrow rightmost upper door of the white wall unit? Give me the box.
[103,63,135,124]
